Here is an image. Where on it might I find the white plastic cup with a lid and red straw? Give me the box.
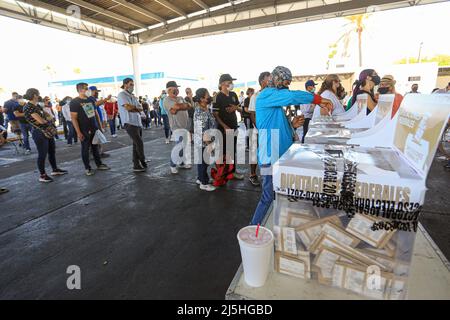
[237,226,274,288]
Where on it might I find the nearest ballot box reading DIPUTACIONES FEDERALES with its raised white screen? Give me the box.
[273,95,450,300]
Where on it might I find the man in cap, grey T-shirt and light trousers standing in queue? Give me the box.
[164,81,191,174]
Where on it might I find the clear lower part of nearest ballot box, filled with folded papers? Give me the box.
[273,194,416,300]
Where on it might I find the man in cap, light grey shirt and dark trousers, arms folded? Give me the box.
[117,78,147,172]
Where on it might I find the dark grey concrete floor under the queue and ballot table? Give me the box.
[0,128,450,299]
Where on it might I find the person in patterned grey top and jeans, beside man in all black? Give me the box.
[193,88,216,192]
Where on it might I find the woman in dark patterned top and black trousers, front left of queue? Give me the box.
[24,88,67,183]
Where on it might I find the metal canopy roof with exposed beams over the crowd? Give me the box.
[0,0,445,44]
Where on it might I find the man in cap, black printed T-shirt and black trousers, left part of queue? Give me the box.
[70,82,110,176]
